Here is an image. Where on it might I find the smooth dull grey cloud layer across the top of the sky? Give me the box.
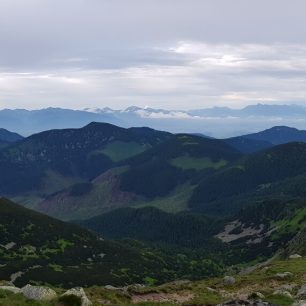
[0,0,306,64]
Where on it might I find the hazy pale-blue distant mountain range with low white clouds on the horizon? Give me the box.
[0,104,306,138]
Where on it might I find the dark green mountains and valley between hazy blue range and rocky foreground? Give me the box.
[0,123,306,306]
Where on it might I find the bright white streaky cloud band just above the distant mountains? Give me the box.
[0,41,306,110]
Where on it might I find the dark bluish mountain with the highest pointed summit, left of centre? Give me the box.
[0,123,170,196]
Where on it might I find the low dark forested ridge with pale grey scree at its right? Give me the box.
[78,199,306,265]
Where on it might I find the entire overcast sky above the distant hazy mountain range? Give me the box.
[0,0,306,109]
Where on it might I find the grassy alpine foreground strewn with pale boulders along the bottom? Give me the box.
[0,255,306,306]
